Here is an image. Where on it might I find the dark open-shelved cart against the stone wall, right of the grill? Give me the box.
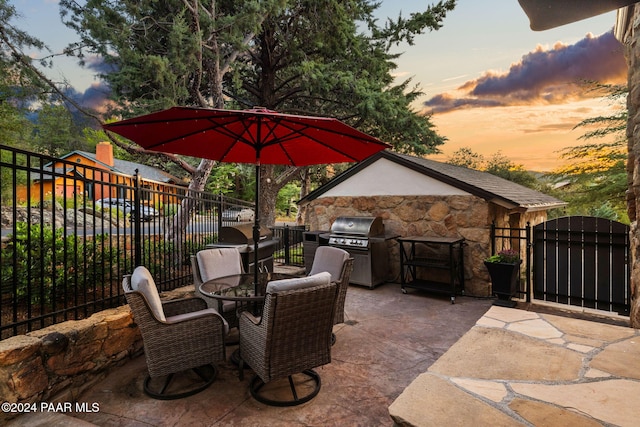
[398,236,464,304]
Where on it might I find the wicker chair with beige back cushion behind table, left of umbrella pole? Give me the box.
[191,248,244,328]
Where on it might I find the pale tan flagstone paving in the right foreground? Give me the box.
[389,306,640,426]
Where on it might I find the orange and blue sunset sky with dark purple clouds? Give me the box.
[12,0,626,171]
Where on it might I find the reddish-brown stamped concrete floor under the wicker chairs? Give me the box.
[8,283,491,427]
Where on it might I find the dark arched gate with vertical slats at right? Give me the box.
[532,216,631,316]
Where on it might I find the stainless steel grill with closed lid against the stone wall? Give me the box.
[329,216,389,289]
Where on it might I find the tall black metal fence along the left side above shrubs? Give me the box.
[0,145,262,339]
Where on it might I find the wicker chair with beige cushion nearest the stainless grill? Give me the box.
[309,246,353,342]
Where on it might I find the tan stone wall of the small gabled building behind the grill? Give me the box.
[305,195,500,297]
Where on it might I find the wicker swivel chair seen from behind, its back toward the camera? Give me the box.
[239,272,337,406]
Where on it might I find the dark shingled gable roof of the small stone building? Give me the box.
[300,150,566,211]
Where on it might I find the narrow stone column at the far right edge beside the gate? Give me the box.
[623,6,640,328]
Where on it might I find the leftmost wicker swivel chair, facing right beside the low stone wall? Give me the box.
[122,266,229,400]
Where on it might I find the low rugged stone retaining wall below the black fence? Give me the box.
[0,305,142,421]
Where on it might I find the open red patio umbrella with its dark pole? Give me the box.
[103,107,389,283]
